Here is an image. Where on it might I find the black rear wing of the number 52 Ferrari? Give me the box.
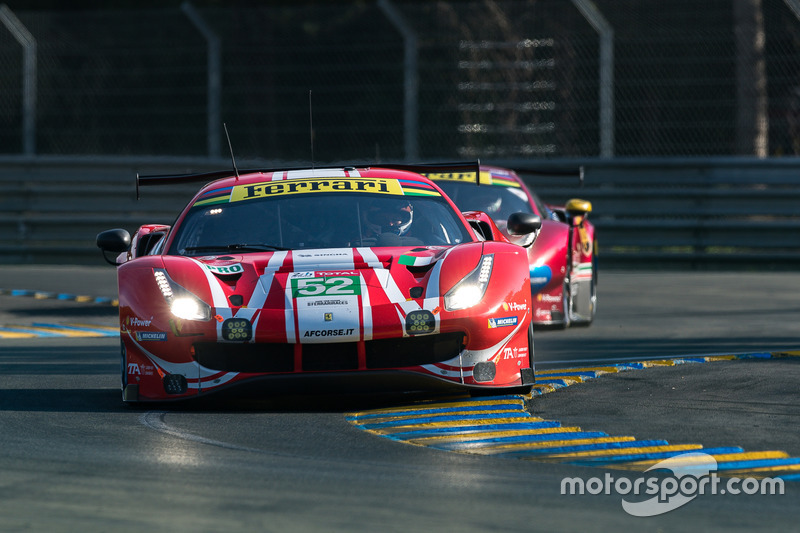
[136,160,481,200]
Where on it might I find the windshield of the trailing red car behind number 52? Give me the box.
[437,181,541,222]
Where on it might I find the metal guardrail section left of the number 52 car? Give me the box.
[0,157,212,264]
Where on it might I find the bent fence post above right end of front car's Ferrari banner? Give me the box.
[378,0,419,161]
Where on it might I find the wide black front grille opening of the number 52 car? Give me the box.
[194,333,464,373]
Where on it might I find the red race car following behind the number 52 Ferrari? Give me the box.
[425,166,597,328]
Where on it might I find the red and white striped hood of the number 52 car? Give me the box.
[164,243,481,343]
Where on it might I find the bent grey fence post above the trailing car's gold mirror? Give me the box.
[572,0,614,158]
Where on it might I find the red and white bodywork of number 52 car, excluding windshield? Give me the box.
[104,168,533,401]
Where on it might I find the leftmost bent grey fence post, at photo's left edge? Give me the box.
[0,4,37,156]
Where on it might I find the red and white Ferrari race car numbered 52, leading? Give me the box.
[97,164,542,402]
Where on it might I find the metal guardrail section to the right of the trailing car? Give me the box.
[508,158,800,269]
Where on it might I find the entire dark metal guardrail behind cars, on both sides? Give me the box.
[0,158,800,269]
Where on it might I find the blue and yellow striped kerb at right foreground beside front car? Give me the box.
[347,352,800,480]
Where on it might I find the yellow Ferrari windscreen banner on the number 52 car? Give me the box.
[230,177,403,202]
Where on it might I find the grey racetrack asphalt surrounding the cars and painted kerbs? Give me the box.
[0,265,800,533]
